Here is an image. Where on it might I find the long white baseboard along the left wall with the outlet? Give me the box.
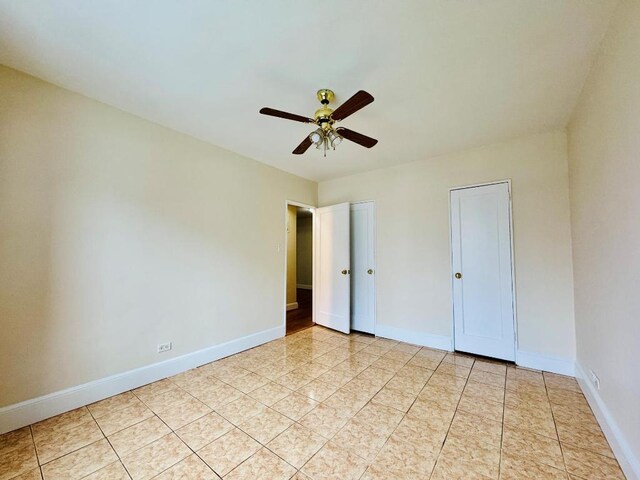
[0,326,285,434]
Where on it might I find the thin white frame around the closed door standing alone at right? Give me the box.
[448,178,518,356]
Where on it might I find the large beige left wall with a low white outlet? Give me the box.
[0,67,316,406]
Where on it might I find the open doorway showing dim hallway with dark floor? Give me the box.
[285,203,314,335]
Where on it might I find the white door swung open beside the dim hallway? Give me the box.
[313,203,351,333]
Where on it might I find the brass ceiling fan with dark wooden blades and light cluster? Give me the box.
[260,88,378,157]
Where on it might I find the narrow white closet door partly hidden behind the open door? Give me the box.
[351,202,375,333]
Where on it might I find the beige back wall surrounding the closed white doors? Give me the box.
[318,132,575,365]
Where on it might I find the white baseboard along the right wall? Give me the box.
[576,362,640,480]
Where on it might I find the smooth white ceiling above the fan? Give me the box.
[0,0,617,180]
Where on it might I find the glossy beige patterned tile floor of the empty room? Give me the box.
[0,327,624,480]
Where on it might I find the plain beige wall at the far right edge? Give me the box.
[568,1,640,468]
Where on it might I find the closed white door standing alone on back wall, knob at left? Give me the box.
[451,183,515,360]
